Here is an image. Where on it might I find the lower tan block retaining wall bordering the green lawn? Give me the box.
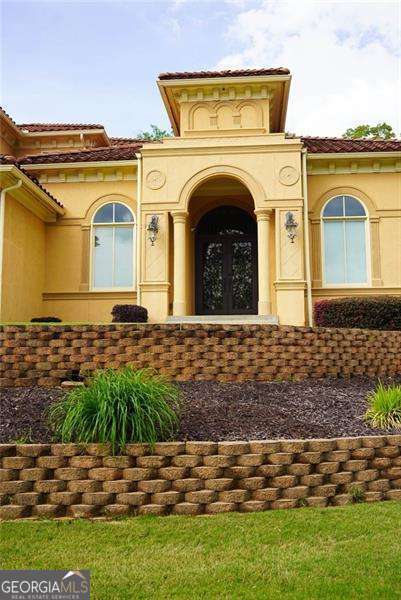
[0,435,401,519]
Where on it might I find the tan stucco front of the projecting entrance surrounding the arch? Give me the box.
[141,134,304,324]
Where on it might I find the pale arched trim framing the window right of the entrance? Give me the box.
[320,194,372,289]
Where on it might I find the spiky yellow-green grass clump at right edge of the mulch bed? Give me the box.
[365,381,401,429]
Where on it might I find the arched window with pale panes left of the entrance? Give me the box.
[92,202,135,290]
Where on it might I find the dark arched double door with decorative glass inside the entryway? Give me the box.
[195,206,257,315]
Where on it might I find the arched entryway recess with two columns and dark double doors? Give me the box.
[170,168,274,318]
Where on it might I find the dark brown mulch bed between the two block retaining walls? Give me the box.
[0,377,401,443]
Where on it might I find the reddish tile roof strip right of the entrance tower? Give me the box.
[301,136,401,153]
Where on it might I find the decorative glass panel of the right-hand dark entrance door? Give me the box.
[231,241,253,312]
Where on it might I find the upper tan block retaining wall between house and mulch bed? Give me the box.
[0,324,401,387]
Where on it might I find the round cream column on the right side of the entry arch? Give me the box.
[255,208,272,315]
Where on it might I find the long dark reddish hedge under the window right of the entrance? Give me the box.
[314,296,401,331]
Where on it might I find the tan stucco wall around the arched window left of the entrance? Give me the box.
[30,180,136,322]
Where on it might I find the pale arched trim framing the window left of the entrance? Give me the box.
[89,200,137,292]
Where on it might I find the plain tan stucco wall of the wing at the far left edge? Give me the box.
[0,194,45,321]
